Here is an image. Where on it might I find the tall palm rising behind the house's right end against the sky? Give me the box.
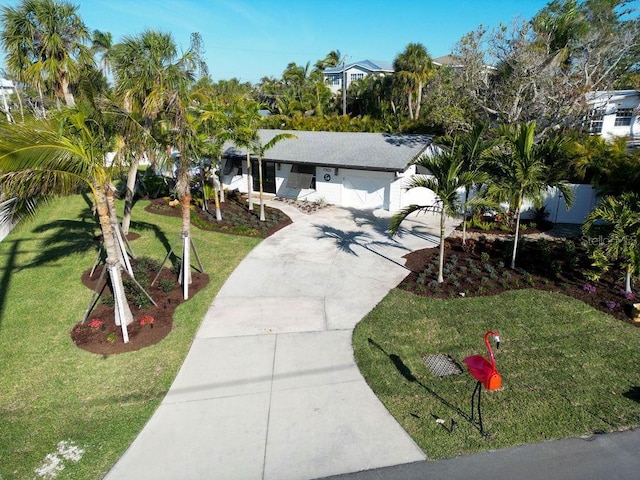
[393,43,434,120]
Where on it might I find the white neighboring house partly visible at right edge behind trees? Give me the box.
[587,90,640,147]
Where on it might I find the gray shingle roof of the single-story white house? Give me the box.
[223,130,433,171]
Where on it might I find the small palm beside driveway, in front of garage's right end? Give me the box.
[389,149,480,283]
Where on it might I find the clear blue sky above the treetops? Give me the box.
[2,0,547,83]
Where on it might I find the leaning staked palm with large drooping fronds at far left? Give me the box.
[0,110,138,342]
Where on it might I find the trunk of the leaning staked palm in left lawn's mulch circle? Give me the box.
[96,187,133,332]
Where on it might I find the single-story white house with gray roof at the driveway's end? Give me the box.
[223,130,434,212]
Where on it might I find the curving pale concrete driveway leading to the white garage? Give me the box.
[106,203,460,480]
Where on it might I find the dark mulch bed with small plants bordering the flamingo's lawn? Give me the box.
[399,234,640,323]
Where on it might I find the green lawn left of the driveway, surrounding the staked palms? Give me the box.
[0,196,259,479]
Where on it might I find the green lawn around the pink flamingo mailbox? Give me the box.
[353,289,640,459]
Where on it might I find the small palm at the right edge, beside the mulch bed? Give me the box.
[582,192,640,293]
